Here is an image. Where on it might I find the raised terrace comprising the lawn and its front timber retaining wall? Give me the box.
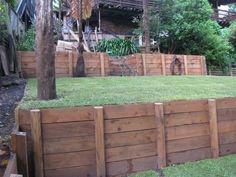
[16,77,236,177]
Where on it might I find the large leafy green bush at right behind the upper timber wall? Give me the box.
[136,0,232,69]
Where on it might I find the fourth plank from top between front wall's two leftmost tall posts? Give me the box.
[44,150,96,170]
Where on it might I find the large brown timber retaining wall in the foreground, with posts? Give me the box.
[17,98,236,177]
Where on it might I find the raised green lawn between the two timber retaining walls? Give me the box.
[20,76,236,109]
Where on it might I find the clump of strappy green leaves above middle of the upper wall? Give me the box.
[97,38,138,56]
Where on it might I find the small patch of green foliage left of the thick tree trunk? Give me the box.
[16,27,36,51]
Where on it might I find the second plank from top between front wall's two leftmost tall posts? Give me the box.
[42,121,94,139]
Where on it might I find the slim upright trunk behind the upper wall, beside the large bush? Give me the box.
[143,0,150,53]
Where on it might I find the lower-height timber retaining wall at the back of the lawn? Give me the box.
[18,52,207,77]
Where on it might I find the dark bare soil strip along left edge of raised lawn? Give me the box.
[0,76,26,144]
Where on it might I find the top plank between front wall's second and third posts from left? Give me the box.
[104,104,154,119]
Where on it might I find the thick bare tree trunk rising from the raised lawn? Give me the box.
[35,0,56,100]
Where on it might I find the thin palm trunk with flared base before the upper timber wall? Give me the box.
[75,0,85,77]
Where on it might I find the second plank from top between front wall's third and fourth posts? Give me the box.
[165,111,209,127]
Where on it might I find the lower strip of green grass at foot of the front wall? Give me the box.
[129,155,236,177]
